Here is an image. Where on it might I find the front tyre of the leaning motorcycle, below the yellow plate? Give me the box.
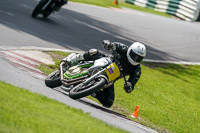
[69,77,106,99]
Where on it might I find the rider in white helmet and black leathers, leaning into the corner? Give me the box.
[66,40,146,108]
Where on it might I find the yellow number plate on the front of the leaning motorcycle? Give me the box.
[106,63,120,81]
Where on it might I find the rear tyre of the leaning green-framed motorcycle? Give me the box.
[45,70,62,88]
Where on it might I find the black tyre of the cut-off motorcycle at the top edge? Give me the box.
[32,0,49,18]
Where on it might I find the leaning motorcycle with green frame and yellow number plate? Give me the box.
[45,51,127,99]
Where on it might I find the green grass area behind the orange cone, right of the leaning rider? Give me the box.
[38,51,200,133]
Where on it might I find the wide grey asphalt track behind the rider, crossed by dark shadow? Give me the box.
[0,0,200,62]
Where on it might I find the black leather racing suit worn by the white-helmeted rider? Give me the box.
[83,42,141,107]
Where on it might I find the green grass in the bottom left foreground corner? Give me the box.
[0,82,125,133]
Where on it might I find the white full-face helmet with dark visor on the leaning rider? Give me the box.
[127,42,146,66]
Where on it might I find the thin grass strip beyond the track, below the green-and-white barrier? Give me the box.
[70,0,172,17]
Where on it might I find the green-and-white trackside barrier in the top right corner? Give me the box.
[125,0,200,21]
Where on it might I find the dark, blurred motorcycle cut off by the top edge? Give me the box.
[32,0,68,18]
